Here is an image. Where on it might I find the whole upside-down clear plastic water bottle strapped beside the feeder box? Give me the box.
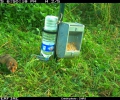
[41,15,58,58]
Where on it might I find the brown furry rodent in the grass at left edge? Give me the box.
[0,54,18,72]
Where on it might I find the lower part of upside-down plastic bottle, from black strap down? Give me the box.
[41,30,56,58]
